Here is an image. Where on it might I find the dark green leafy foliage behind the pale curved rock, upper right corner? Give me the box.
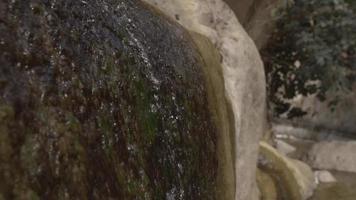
[263,0,356,118]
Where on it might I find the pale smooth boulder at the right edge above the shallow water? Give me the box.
[307,141,356,173]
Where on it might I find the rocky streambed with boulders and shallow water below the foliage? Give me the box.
[258,128,356,200]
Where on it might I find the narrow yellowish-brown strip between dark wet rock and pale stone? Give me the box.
[186,33,235,199]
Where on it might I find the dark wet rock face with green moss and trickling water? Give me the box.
[0,0,217,200]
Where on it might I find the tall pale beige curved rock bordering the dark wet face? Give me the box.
[145,0,265,200]
